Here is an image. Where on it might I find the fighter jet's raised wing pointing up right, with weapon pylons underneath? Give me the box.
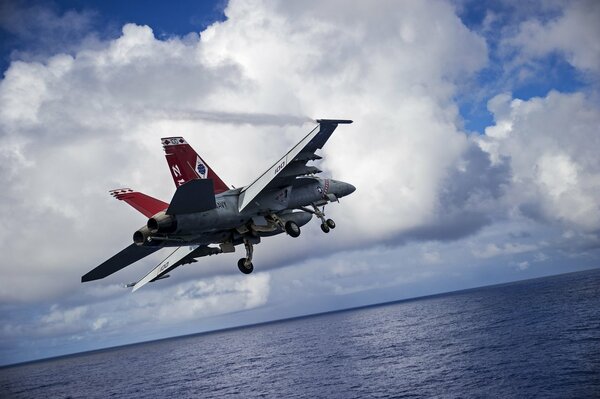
[238,119,352,212]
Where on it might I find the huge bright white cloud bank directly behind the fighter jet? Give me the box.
[0,1,486,300]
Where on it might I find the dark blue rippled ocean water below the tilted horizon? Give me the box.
[0,269,600,398]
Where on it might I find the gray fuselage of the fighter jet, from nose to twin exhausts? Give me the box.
[134,177,355,246]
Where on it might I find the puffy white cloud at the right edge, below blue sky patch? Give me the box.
[478,91,600,232]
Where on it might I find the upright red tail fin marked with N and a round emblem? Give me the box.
[161,137,229,194]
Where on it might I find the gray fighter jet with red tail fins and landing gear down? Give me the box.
[81,119,355,291]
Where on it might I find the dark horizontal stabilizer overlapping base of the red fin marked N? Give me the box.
[166,179,217,215]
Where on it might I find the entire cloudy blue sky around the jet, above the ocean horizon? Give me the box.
[0,0,600,364]
